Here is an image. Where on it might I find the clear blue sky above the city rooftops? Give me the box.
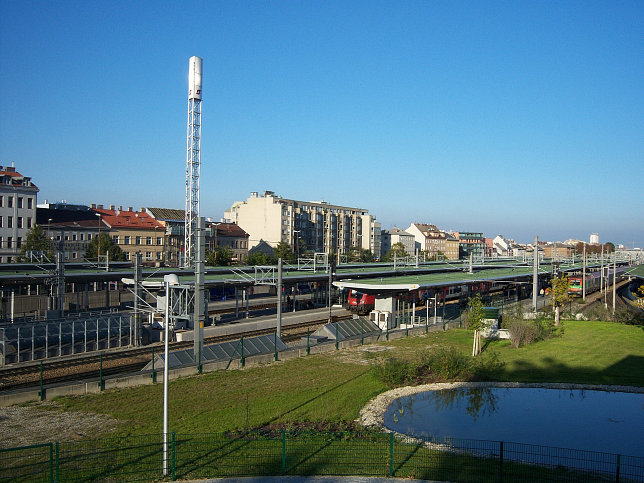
[0,0,644,247]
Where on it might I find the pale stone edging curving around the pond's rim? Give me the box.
[357,382,644,429]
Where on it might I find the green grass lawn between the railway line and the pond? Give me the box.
[57,321,644,436]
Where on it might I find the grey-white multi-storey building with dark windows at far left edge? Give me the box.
[0,166,38,263]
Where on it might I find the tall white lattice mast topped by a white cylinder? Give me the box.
[183,56,203,268]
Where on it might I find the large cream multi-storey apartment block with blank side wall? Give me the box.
[224,191,380,257]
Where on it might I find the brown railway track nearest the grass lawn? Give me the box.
[0,316,350,391]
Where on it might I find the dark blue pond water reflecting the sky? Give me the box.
[384,387,644,457]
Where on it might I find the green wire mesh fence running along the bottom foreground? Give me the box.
[0,430,644,483]
